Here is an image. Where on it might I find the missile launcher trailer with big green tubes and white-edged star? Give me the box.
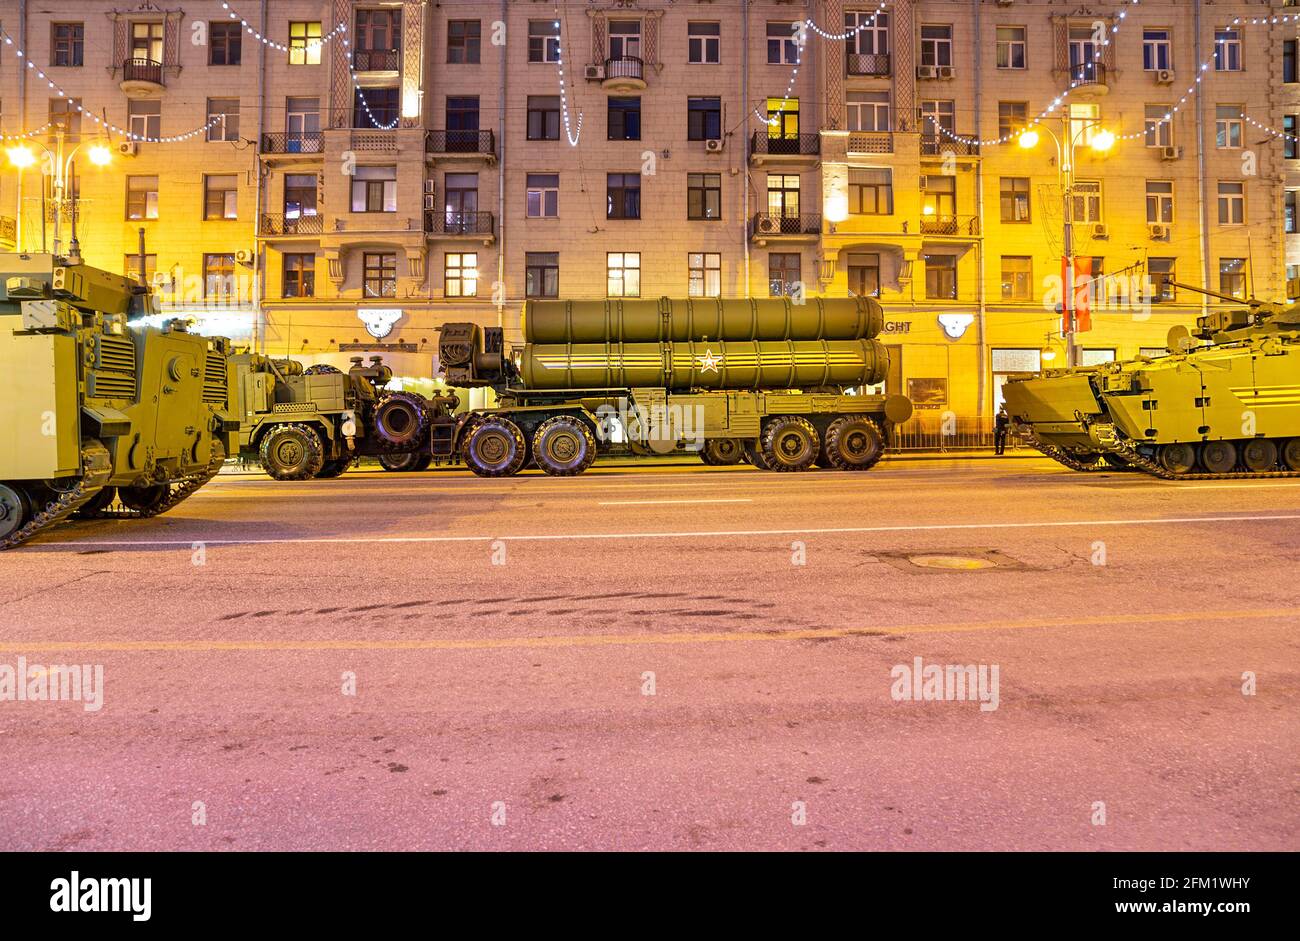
[430,298,911,477]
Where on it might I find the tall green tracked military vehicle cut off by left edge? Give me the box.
[0,253,238,548]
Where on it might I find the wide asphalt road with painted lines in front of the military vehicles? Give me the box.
[0,459,1300,850]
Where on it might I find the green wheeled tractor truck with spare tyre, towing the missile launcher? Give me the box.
[231,354,458,481]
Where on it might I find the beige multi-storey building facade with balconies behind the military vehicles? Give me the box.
[0,0,1300,424]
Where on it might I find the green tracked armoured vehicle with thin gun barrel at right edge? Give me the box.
[1004,285,1300,480]
